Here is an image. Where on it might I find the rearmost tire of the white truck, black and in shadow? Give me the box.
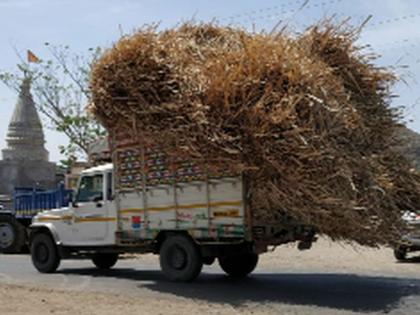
[219,253,258,278]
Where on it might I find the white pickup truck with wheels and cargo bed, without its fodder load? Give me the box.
[30,135,316,281]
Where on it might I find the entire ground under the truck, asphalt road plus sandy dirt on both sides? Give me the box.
[0,240,420,315]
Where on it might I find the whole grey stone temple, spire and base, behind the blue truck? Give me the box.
[0,78,57,196]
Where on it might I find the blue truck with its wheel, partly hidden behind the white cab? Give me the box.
[0,184,72,253]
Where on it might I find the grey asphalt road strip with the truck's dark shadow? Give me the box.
[0,255,420,315]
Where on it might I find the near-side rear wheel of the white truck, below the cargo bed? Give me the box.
[159,235,203,282]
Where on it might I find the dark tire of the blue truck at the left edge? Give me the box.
[0,216,26,254]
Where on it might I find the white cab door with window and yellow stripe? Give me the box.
[73,174,111,245]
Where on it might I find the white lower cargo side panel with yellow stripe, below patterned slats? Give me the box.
[119,177,244,239]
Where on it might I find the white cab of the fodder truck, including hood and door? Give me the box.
[31,164,117,246]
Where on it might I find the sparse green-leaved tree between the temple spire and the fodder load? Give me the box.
[0,43,105,166]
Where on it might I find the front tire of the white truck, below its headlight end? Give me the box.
[31,233,61,273]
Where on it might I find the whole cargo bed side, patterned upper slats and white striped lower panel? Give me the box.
[109,128,245,239]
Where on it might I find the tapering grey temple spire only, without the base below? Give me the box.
[2,75,48,161]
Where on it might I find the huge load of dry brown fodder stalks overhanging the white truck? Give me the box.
[90,23,420,245]
